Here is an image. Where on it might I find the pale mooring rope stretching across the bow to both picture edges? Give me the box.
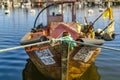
[0,39,120,53]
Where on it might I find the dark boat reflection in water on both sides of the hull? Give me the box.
[23,59,100,80]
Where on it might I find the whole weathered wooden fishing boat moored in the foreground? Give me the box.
[21,1,115,80]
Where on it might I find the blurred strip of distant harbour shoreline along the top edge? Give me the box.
[0,0,120,7]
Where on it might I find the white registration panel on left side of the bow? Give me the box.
[35,49,55,65]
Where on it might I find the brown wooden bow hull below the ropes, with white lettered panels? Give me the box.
[26,44,101,80]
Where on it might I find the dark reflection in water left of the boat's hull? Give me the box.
[23,59,55,80]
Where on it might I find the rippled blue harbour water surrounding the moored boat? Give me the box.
[0,7,120,80]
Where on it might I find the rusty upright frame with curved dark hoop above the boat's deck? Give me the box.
[34,1,76,28]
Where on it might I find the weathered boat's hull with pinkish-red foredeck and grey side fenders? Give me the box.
[21,23,103,80]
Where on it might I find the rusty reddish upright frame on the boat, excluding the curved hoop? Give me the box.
[47,1,76,25]
